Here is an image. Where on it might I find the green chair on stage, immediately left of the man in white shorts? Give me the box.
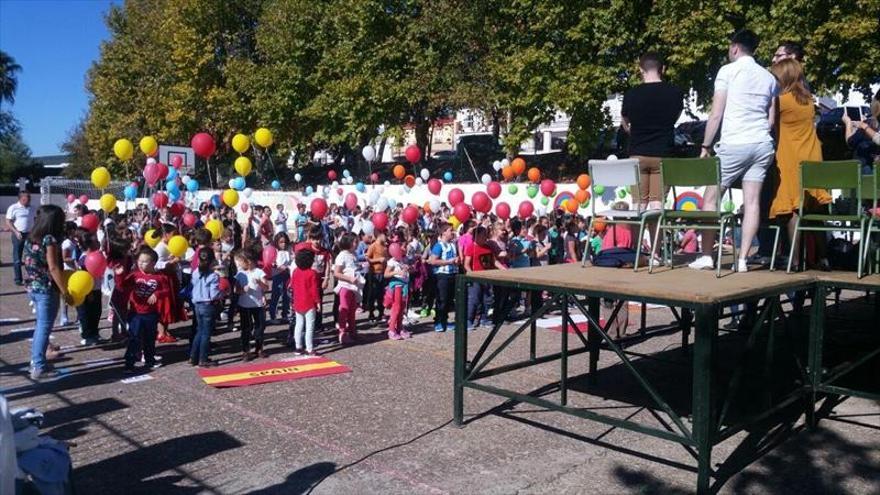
[648,157,736,277]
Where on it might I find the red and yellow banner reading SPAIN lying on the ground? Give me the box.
[199,357,351,388]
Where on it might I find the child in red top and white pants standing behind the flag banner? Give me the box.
[290,249,321,356]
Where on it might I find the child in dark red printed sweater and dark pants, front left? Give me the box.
[123,246,171,373]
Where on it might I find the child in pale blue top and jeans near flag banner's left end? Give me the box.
[189,249,223,368]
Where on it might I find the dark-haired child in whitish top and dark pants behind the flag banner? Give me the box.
[233,250,269,361]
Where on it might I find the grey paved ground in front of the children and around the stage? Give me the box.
[0,234,880,494]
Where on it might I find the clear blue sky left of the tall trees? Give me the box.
[0,0,119,156]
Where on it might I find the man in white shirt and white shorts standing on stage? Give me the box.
[689,30,778,272]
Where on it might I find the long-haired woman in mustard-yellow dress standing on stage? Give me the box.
[770,59,832,267]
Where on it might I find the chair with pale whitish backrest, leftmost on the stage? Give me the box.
[581,159,660,271]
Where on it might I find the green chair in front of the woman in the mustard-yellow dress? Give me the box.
[786,160,867,278]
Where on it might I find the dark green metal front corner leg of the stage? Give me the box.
[692,304,719,493]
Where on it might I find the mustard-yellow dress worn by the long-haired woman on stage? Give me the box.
[770,93,832,218]
